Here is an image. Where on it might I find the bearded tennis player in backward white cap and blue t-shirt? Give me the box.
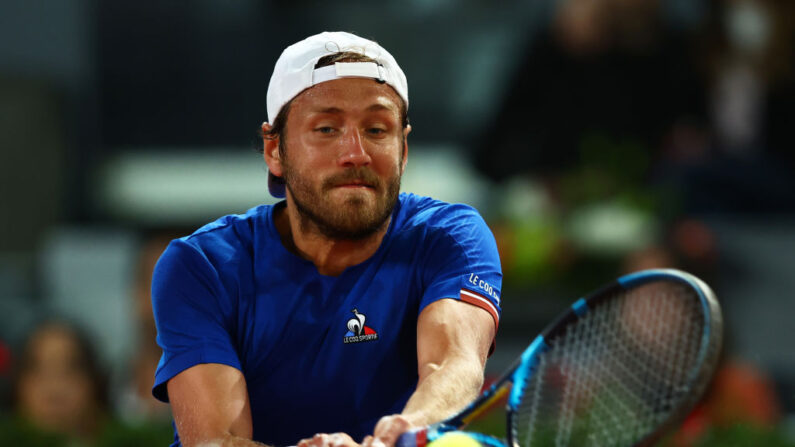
[152,33,502,447]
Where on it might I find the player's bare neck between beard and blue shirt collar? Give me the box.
[274,203,392,276]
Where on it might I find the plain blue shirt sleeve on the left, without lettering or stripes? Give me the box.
[152,239,241,402]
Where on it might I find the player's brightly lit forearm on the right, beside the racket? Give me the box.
[402,355,484,426]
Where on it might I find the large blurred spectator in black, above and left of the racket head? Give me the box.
[477,0,705,184]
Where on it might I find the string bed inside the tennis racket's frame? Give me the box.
[512,282,704,447]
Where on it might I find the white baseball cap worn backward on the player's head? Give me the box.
[267,31,409,197]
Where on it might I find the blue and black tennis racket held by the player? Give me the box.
[396,269,723,447]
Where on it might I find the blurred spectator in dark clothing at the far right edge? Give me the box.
[658,0,795,214]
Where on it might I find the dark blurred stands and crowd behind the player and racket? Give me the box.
[0,0,795,446]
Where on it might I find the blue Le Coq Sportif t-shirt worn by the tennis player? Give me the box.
[152,194,502,445]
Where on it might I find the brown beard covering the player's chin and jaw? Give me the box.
[285,173,400,241]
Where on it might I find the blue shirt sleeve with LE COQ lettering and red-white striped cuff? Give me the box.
[420,205,502,326]
